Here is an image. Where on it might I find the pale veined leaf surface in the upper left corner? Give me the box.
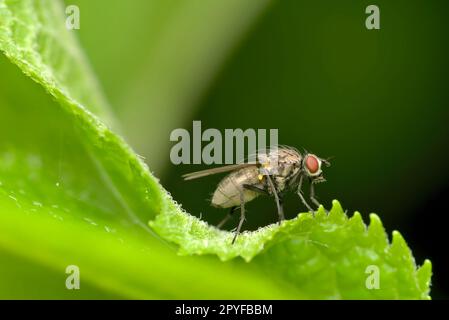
[0,0,114,127]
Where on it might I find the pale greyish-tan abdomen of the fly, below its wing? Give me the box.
[211,167,261,208]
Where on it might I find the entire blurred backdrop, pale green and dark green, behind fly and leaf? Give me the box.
[66,0,449,298]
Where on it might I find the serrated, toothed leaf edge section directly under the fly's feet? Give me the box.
[150,201,431,299]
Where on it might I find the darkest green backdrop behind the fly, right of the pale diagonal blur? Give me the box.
[159,0,449,299]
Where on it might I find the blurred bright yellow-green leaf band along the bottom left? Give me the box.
[0,189,293,299]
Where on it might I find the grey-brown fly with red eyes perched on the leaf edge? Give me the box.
[182,146,330,243]
